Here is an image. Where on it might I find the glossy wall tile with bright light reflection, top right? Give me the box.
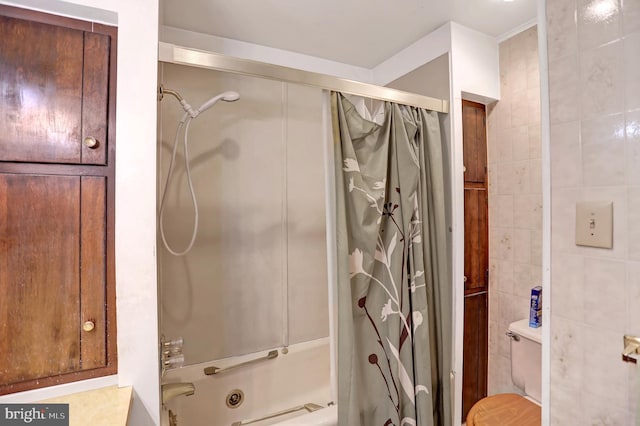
[578,0,621,49]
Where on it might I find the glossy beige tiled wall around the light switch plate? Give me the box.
[547,0,640,425]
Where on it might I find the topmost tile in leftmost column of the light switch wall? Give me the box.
[547,0,578,60]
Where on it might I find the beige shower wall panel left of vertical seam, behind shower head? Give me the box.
[159,64,286,364]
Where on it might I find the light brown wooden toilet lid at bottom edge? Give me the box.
[467,393,542,426]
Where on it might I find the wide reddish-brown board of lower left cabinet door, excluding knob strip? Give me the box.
[0,174,80,384]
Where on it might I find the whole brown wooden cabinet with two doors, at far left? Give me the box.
[0,5,116,394]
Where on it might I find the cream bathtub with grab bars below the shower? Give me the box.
[162,338,337,426]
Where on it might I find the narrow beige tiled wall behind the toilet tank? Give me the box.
[487,27,542,395]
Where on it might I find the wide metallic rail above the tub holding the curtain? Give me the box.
[158,42,449,113]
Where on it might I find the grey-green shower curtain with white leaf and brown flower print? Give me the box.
[331,92,452,426]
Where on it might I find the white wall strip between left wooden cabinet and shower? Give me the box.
[2,0,159,426]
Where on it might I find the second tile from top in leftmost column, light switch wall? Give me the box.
[549,55,580,124]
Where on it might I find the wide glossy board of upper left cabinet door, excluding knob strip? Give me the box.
[0,16,83,163]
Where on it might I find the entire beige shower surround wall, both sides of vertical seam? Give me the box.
[159,63,328,364]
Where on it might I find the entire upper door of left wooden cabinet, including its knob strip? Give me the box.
[0,16,110,164]
